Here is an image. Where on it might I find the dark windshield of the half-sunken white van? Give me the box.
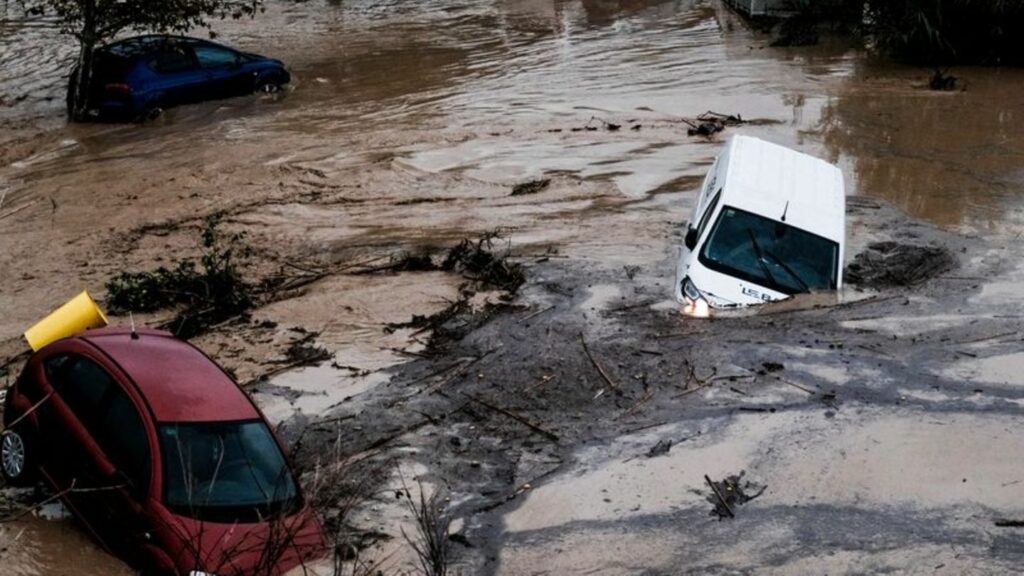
[698,206,839,294]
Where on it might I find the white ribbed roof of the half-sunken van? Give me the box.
[721,135,846,244]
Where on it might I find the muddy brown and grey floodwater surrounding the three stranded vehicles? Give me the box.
[0,0,1024,576]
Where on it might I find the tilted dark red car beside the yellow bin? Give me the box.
[0,329,324,576]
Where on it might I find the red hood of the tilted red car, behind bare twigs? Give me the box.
[155,508,325,576]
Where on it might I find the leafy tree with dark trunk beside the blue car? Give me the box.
[11,0,263,120]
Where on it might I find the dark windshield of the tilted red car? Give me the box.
[159,420,300,522]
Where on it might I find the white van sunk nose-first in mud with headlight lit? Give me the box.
[676,135,846,316]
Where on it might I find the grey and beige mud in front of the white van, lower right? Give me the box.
[299,198,1024,574]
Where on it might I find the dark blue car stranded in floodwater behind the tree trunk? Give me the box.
[68,35,291,120]
